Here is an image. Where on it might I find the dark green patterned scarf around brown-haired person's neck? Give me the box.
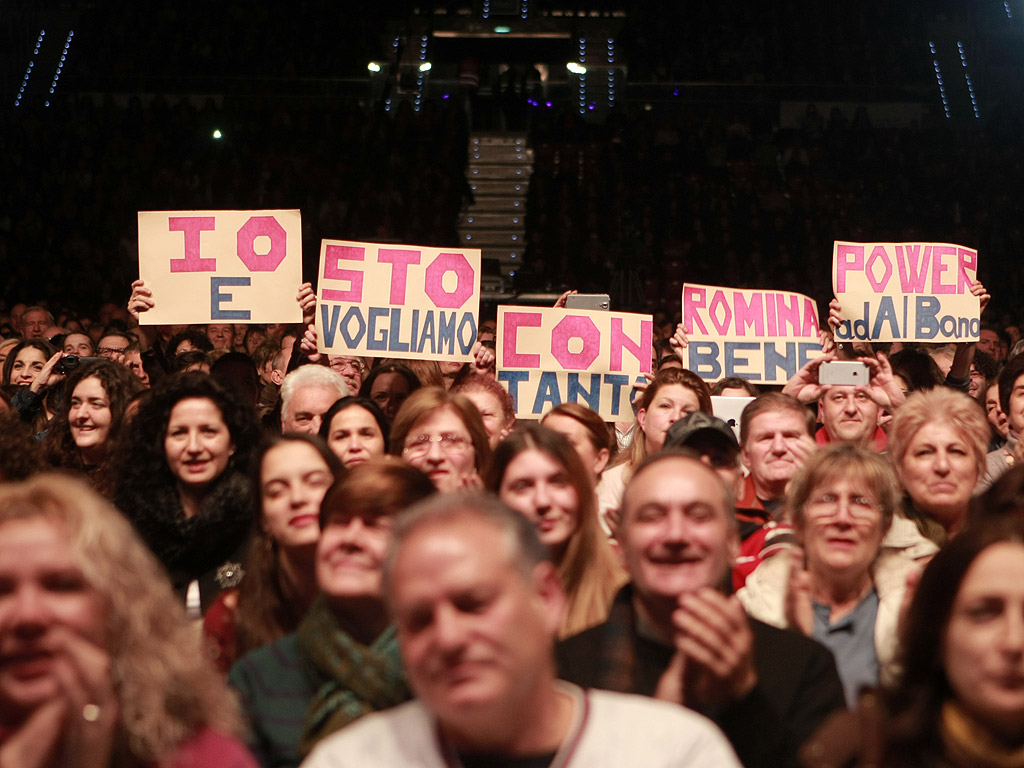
[297,596,410,755]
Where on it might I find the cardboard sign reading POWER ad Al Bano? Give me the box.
[833,241,981,342]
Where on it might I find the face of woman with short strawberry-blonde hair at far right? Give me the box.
[896,421,978,530]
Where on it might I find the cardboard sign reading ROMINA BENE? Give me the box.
[683,283,821,384]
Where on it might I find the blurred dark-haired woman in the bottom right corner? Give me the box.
[802,506,1024,768]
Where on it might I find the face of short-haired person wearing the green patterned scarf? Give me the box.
[316,511,391,603]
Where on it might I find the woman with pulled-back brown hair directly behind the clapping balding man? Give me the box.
[597,368,712,527]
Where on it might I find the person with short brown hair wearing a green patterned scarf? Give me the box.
[228,457,435,766]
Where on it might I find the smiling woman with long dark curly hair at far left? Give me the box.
[43,359,142,490]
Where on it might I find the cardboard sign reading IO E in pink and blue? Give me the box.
[138,211,302,326]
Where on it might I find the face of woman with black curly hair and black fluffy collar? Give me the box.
[164,397,234,490]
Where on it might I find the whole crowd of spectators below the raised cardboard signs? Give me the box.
[0,281,1024,768]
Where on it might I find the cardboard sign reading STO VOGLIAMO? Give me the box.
[316,240,480,362]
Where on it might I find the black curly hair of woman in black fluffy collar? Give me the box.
[118,371,260,501]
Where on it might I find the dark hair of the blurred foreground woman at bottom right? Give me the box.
[886,514,1024,765]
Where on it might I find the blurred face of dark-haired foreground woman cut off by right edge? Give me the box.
[942,542,1024,744]
